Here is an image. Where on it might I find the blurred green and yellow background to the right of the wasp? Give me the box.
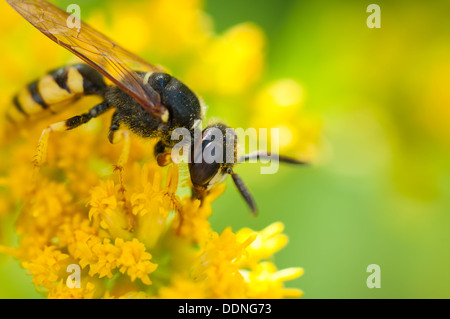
[0,0,450,298]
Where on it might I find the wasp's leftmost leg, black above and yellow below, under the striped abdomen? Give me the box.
[34,102,110,169]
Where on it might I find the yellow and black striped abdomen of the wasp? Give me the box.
[6,64,106,122]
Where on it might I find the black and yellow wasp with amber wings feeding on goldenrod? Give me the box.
[6,0,305,213]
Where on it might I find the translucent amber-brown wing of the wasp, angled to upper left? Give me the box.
[7,0,168,121]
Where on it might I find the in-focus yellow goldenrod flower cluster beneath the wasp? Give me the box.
[1,121,302,298]
